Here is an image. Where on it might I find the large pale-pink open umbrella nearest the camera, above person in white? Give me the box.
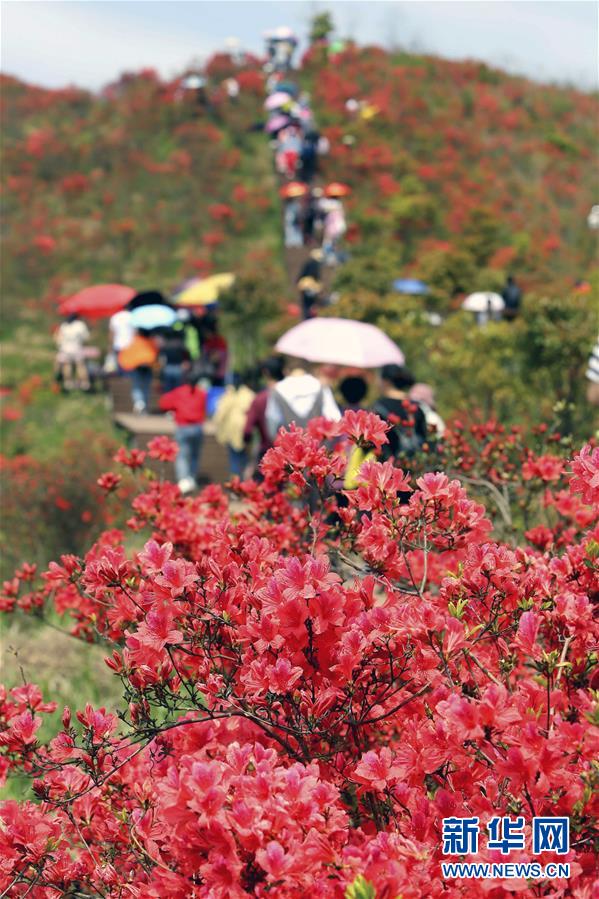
[276,318,405,368]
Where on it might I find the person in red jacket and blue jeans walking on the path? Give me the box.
[160,372,207,493]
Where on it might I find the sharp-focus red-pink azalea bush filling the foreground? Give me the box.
[0,412,599,899]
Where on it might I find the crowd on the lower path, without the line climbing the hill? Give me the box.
[57,300,444,493]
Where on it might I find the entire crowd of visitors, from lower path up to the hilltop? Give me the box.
[56,28,599,493]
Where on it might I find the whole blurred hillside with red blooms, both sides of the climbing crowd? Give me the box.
[2,40,599,442]
